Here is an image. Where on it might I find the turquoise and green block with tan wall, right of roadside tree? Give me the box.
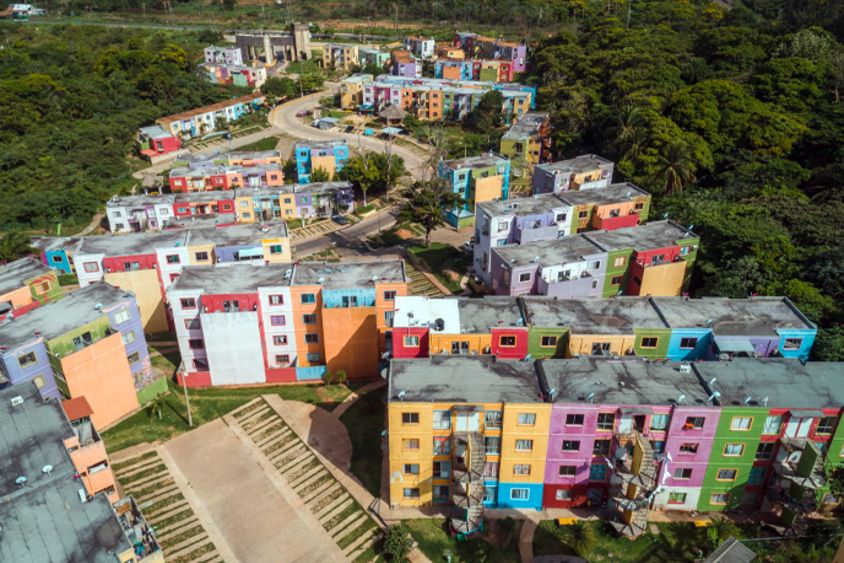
[439,153,510,228]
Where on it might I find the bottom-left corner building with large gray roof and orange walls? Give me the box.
[0,383,164,563]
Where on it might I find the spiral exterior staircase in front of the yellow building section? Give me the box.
[450,432,486,537]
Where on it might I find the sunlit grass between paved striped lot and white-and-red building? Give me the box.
[103,378,350,452]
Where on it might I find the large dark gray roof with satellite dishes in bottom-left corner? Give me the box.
[0,384,132,563]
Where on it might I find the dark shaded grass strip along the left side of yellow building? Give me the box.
[340,387,387,497]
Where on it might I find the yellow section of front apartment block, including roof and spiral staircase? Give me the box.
[387,356,551,533]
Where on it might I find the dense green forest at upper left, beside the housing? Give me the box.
[0,24,231,231]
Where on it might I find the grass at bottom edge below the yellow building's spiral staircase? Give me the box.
[404,518,522,563]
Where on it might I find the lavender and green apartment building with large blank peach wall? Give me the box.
[0,283,158,428]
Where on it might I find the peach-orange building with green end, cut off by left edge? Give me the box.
[0,257,63,318]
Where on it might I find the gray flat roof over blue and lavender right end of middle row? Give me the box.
[653,297,815,335]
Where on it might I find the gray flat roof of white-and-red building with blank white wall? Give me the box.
[170,264,293,294]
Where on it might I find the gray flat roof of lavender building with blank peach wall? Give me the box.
[0,282,133,348]
